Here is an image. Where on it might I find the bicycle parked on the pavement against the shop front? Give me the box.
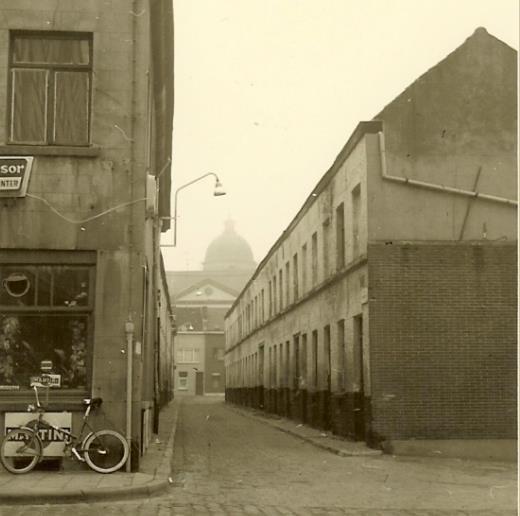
[0,385,130,474]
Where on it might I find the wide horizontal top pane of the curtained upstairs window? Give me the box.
[13,36,90,65]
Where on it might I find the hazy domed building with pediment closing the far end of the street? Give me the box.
[166,220,256,395]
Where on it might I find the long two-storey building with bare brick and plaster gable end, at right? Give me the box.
[226,28,517,456]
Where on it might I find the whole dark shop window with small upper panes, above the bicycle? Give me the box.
[0,262,95,390]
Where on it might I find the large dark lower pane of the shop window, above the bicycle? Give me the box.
[0,313,88,388]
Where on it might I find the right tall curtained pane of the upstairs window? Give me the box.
[54,72,89,145]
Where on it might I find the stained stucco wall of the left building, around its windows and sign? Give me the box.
[0,0,172,460]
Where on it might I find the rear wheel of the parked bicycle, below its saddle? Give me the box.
[83,430,130,473]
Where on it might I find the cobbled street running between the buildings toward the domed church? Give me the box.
[0,397,516,516]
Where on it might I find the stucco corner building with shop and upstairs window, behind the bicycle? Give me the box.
[0,0,173,466]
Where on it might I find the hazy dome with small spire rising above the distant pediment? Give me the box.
[203,220,256,271]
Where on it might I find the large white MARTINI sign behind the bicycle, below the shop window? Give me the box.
[4,412,72,457]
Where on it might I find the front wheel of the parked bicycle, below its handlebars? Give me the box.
[0,428,43,474]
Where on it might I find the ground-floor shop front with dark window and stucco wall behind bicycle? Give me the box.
[0,250,172,468]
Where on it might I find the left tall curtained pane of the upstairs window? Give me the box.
[11,70,48,143]
